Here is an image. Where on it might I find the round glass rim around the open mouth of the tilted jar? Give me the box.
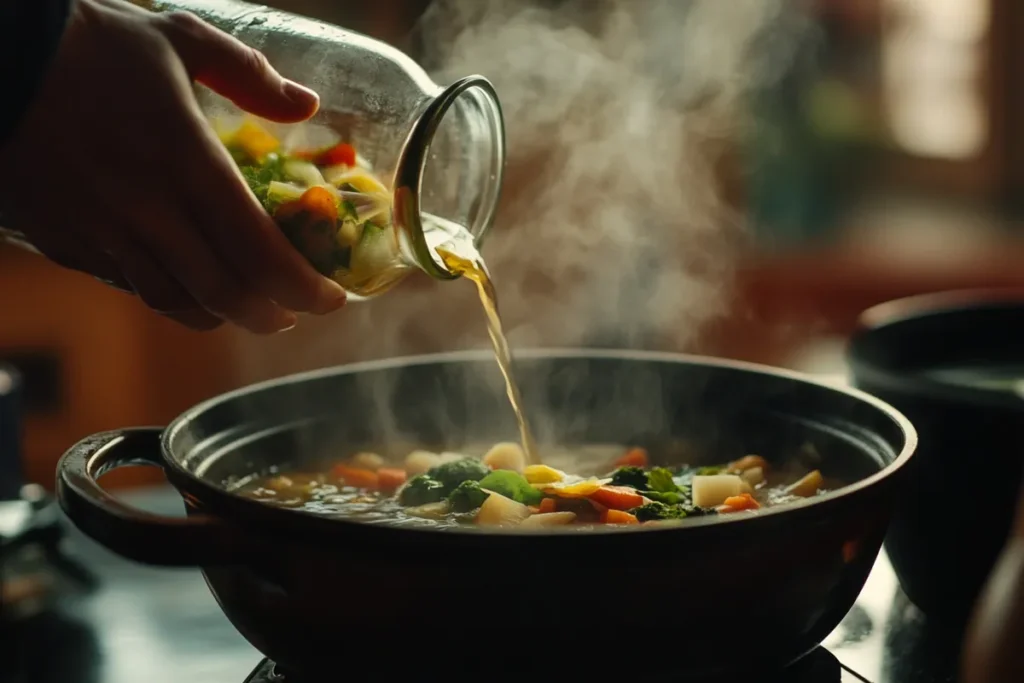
[393,76,505,280]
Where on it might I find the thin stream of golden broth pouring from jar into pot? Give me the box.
[437,241,541,465]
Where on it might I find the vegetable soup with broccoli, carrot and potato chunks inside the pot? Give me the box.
[231,442,842,530]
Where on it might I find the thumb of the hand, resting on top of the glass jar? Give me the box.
[161,12,319,123]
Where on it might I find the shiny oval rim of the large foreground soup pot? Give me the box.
[160,347,918,555]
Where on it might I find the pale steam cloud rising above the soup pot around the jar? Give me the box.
[234,0,809,387]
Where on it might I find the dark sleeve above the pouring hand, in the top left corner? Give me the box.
[0,0,75,145]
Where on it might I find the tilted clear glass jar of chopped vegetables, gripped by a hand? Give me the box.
[7,0,505,300]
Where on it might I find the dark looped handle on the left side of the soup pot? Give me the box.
[56,427,243,566]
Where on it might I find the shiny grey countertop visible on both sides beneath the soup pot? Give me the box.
[0,488,959,683]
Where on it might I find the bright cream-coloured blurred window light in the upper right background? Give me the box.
[882,0,990,159]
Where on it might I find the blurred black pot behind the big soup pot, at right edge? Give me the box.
[848,290,1024,625]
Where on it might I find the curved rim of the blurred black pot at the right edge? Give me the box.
[846,288,1024,414]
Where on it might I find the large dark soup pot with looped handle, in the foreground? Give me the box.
[57,350,916,680]
